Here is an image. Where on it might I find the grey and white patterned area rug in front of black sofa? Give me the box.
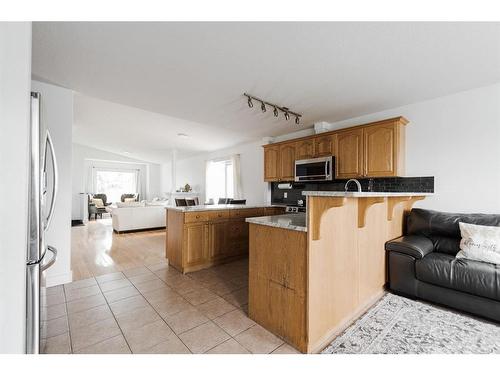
[323,293,500,354]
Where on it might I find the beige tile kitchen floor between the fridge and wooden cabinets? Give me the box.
[42,260,297,354]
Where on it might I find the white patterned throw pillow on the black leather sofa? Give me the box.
[457,223,500,264]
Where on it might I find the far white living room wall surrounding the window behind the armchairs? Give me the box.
[72,143,162,220]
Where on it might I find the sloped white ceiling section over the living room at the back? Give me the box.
[73,93,250,163]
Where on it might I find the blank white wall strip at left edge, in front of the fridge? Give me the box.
[0,22,31,353]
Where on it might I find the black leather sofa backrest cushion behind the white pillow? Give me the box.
[406,208,500,256]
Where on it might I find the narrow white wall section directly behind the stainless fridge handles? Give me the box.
[31,81,73,286]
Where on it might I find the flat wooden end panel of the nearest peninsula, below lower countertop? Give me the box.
[248,224,307,351]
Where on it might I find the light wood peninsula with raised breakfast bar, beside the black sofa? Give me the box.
[247,191,431,353]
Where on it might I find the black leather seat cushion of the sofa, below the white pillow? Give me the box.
[415,252,500,301]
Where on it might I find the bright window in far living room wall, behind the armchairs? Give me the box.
[93,169,138,202]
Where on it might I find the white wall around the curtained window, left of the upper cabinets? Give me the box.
[170,142,269,204]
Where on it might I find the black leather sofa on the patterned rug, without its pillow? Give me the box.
[385,209,500,322]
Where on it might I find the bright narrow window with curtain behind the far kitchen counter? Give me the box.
[206,159,234,203]
